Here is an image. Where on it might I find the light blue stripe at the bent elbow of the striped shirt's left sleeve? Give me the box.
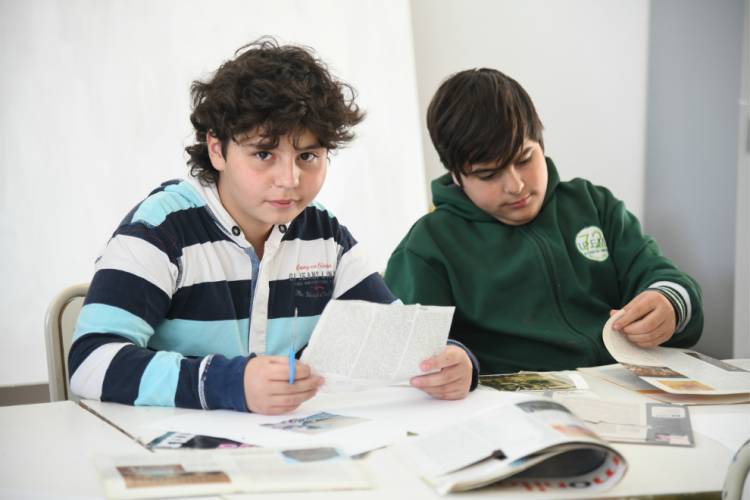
[73,304,154,347]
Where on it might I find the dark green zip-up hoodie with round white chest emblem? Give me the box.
[385,158,703,373]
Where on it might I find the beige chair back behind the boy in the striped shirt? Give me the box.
[44,283,89,401]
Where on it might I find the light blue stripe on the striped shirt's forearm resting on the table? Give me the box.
[133,351,182,406]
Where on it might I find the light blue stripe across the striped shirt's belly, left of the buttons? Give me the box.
[149,319,249,357]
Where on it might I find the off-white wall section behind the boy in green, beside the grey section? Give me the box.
[411,0,649,216]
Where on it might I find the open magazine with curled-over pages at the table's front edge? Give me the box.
[395,393,627,495]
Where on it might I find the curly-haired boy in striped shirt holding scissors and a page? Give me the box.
[69,38,478,414]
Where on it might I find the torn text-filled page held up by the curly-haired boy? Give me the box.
[301,300,454,391]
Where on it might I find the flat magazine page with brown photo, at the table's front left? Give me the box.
[96,447,372,499]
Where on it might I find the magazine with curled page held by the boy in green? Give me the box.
[602,315,750,395]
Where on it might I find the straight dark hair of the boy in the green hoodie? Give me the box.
[427,68,544,181]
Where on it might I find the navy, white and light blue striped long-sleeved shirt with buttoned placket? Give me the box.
[69,178,402,411]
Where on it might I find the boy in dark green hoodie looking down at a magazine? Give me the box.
[385,68,703,373]
